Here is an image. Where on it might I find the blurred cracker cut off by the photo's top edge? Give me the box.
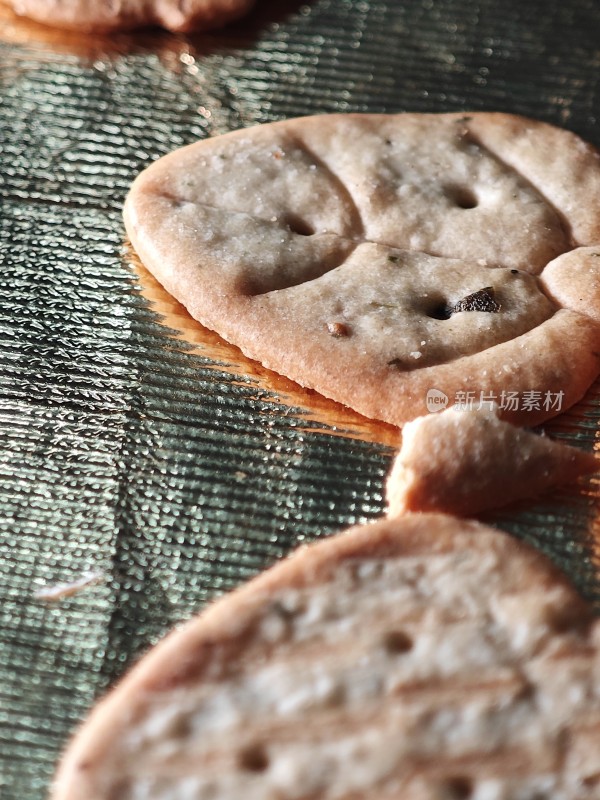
[6,0,254,33]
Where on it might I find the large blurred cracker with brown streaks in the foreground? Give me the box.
[53,514,600,800]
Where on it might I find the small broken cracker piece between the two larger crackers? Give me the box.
[386,408,598,515]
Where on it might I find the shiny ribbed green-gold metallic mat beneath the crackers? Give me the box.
[0,0,600,800]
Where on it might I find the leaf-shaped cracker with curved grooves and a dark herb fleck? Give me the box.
[125,113,600,425]
